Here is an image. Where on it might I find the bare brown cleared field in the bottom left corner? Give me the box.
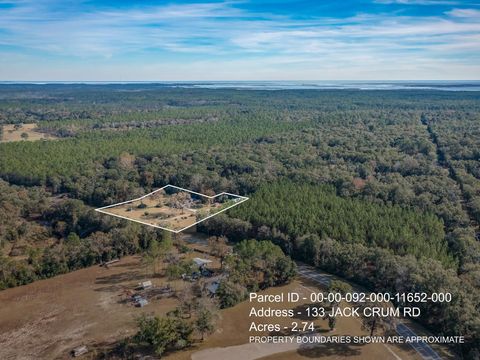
[0,257,180,359]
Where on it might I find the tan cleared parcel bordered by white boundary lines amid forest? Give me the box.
[96,185,248,233]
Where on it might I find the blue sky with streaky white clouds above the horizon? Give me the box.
[0,0,480,81]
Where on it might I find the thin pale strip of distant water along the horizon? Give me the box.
[0,80,480,91]
